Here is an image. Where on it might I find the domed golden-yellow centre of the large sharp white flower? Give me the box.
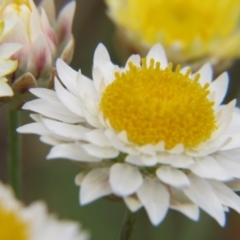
[100,59,216,149]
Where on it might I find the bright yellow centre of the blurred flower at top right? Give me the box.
[106,0,240,48]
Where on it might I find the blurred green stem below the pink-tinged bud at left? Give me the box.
[8,108,22,198]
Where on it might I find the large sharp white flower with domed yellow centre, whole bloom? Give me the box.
[18,44,240,226]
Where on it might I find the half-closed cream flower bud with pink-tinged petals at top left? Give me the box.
[0,0,76,93]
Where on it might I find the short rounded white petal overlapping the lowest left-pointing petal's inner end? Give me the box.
[82,144,119,159]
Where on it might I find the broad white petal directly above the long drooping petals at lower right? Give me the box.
[190,156,232,181]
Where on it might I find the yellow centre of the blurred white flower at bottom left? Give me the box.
[0,202,30,240]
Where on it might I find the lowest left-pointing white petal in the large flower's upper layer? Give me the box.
[47,143,101,162]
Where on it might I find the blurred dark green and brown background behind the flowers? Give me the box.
[0,0,240,240]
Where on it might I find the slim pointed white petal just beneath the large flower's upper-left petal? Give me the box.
[54,78,84,117]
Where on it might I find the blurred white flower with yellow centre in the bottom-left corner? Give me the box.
[0,183,89,240]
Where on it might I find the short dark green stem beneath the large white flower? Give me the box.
[118,209,136,240]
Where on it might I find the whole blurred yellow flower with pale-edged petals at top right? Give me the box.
[106,0,240,69]
